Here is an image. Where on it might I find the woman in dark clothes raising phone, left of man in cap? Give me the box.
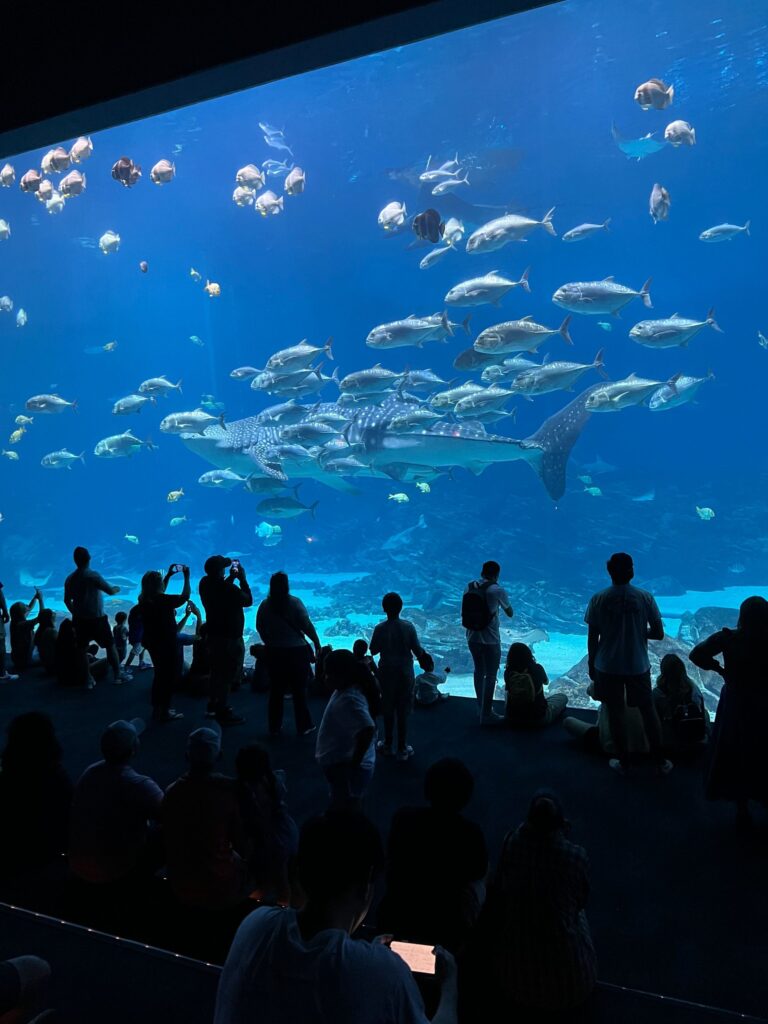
[138,562,189,722]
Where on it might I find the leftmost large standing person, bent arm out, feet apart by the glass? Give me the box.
[65,547,130,689]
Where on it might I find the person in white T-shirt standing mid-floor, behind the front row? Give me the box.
[315,650,376,810]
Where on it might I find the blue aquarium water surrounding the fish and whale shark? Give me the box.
[0,0,768,696]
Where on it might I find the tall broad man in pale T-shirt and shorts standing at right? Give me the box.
[584,552,673,774]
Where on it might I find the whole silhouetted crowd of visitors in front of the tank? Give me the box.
[0,548,768,1024]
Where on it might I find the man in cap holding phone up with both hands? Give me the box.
[200,555,253,725]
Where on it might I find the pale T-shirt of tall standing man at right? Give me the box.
[584,583,662,676]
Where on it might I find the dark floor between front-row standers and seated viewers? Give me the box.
[0,672,768,1016]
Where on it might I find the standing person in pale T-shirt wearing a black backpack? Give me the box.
[462,561,512,725]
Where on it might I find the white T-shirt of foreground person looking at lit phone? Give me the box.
[214,907,428,1024]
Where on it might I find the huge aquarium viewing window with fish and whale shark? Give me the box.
[0,0,768,708]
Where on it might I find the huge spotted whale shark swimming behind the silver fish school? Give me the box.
[180,385,599,501]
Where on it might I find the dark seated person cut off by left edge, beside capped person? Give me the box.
[0,711,72,874]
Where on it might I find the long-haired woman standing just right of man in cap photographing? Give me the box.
[256,572,321,736]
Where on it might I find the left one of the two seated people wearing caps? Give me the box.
[69,718,163,885]
